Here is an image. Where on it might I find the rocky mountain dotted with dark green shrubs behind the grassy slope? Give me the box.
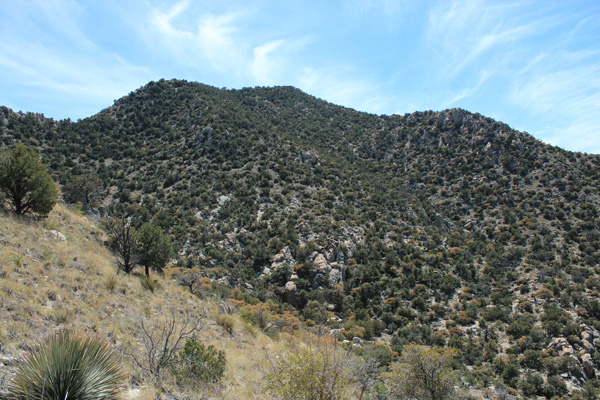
[0,80,600,397]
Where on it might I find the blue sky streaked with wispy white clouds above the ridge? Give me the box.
[0,0,600,154]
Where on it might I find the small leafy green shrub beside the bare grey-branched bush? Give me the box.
[173,338,227,385]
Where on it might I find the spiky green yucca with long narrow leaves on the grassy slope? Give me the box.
[9,332,125,400]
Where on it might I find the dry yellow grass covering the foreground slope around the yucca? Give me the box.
[0,204,310,399]
